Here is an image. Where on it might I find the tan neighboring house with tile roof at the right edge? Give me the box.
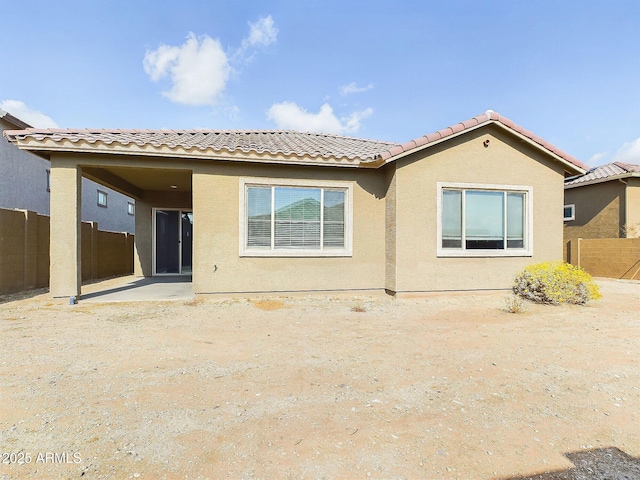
[564,162,640,242]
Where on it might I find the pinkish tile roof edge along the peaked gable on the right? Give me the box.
[381,110,589,171]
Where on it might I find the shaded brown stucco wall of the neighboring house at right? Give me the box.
[564,180,624,243]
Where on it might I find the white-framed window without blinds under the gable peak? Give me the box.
[437,183,533,256]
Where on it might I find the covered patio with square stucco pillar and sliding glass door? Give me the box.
[25,148,193,301]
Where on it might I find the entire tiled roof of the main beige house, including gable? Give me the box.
[4,110,588,173]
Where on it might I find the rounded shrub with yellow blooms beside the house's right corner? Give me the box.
[513,262,602,305]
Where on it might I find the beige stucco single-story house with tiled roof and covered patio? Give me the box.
[5,111,587,297]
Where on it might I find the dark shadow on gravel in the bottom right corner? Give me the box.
[500,447,640,480]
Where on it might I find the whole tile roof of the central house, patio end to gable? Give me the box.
[4,110,589,173]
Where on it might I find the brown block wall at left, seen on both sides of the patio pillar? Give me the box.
[0,209,134,295]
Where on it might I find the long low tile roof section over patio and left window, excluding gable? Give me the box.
[5,128,397,162]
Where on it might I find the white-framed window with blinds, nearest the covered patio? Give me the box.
[240,180,352,256]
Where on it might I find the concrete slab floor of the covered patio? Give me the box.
[80,275,194,303]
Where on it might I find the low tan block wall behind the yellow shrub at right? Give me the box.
[567,238,640,280]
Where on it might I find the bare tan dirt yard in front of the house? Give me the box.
[0,280,640,479]
